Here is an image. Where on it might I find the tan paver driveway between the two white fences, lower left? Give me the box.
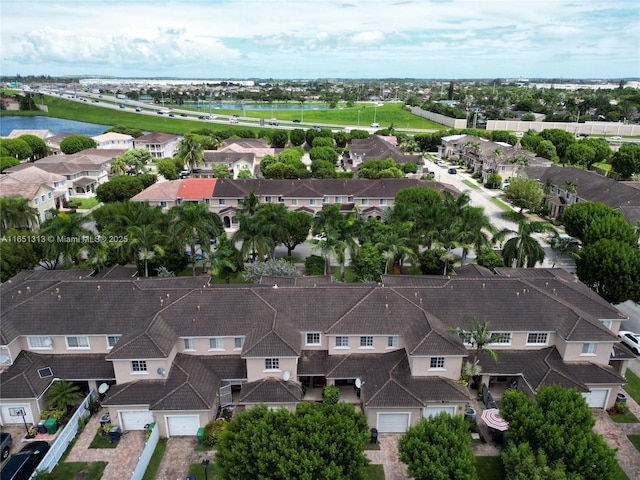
[66,410,144,480]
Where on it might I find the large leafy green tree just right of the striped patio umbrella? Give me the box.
[501,385,616,480]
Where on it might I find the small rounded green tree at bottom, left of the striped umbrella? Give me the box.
[398,412,477,480]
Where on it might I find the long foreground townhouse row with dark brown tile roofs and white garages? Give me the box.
[0,265,632,436]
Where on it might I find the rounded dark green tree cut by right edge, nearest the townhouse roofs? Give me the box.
[576,238,640,304]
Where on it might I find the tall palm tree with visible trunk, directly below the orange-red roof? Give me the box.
[169,202,223,277]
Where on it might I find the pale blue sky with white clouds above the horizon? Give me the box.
[0,0,640,79]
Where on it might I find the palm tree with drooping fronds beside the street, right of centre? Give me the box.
[494,212,555,268]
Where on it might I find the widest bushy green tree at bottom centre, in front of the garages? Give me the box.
[216,402,366,480]
